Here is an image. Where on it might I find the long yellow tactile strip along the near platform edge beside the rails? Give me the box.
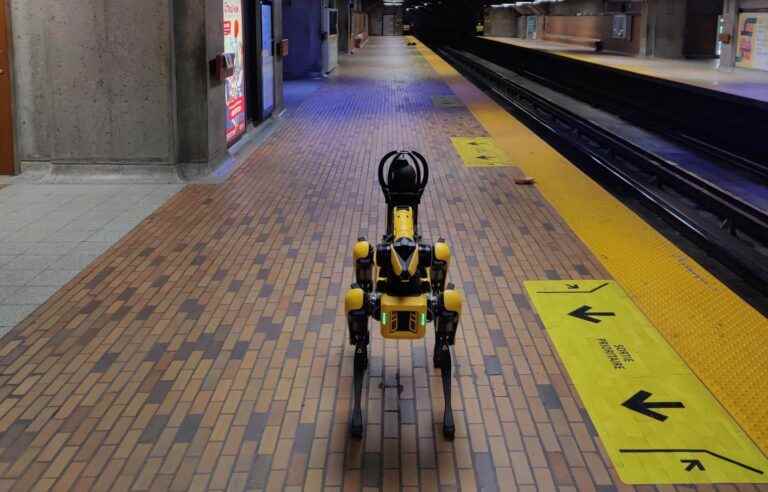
[417,38,768,453]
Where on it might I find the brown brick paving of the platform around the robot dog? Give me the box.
[0,38,755,492]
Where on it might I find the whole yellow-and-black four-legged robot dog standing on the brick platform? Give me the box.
[345,151,461,439]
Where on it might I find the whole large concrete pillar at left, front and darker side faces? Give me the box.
[8,0,283,178]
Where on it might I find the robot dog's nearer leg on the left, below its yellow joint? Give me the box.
[345,284,370,437]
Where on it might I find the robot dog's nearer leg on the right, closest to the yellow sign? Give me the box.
[434,284,461,439]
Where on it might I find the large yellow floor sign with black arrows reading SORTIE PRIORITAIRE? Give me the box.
[525,280,768,484]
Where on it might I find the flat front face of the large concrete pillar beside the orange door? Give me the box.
[11,0,176,175]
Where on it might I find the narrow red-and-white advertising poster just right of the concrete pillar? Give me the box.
[224,0,246,145]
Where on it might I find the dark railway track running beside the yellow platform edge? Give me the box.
[436,47,768,295]
